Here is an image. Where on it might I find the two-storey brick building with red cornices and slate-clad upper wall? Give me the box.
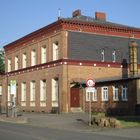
[1,10,140,114]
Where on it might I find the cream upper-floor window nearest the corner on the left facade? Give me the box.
[53,42,59,60]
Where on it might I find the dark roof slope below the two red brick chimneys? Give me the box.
[62,15,140,30]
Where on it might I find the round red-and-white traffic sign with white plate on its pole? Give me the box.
[86,79,95,126]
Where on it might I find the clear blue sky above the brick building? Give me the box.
[0,0,140,48]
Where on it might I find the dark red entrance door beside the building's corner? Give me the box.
[70,88,80,107]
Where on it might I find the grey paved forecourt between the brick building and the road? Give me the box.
[0,113,140,139]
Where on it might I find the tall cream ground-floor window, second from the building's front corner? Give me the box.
[40,80,46,101]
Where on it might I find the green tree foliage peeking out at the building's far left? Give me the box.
[0,49,5,73]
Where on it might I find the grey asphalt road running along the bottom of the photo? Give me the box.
[0,122,139,140]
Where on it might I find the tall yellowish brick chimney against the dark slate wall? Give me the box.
[129,41,138,77]
